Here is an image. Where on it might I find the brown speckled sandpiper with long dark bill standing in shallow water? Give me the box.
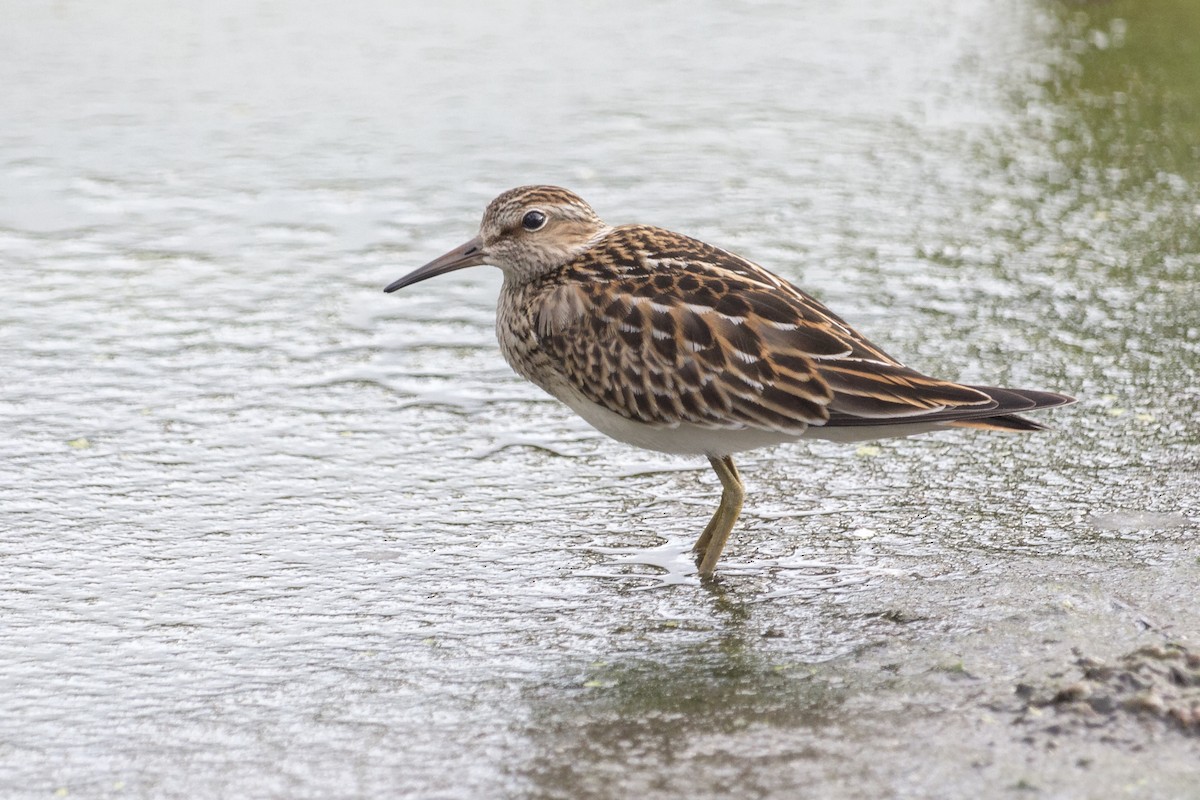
[384,186,1074,579]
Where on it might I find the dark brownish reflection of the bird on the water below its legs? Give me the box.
[517,588,862,796]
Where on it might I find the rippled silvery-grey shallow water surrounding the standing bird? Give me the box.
[0,0,1200,798]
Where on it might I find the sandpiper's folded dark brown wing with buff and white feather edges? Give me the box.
[538,225,1070,435]
